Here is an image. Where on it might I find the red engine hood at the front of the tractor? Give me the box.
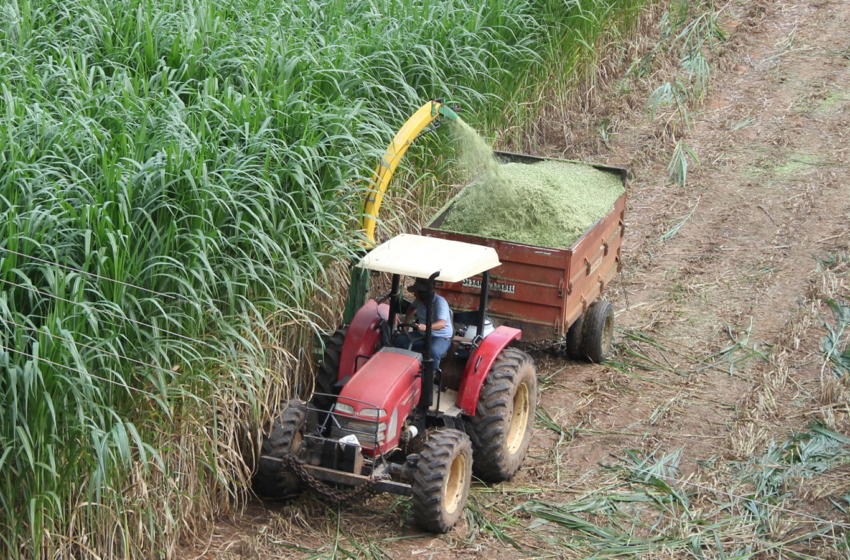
[337,348,422,420]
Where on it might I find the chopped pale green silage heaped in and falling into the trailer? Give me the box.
[440,123,625,249]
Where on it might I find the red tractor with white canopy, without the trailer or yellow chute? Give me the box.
[254,235,537,533]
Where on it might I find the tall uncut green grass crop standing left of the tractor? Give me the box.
[0,0,639,558]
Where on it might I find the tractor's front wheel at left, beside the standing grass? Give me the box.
[253,399,307,498]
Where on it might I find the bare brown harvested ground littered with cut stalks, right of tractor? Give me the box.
[186,1,850,559]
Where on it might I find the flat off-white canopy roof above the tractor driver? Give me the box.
[357,233,502,282]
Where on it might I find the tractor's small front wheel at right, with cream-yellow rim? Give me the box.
[412,429,472,533]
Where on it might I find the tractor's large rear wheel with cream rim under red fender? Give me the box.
[467,348,537,482]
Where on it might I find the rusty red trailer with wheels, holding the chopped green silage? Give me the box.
[422,152,627,361]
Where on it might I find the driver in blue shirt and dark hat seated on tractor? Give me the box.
[394,278,454,369]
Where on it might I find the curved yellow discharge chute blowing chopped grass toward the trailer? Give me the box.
[360,100,457,247]
